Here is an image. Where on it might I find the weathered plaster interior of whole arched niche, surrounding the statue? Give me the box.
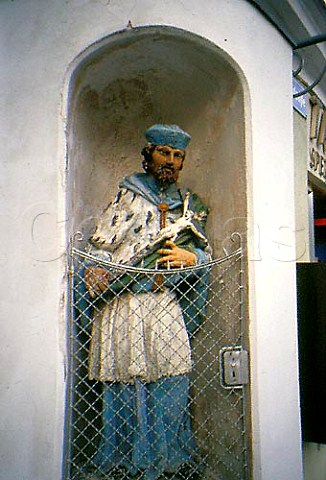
[67,27,250,479]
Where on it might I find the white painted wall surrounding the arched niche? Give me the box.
[0,0,302,480]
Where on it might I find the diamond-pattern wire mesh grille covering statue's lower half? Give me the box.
[65,242,248,480]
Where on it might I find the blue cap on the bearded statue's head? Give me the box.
[145,124,191,150]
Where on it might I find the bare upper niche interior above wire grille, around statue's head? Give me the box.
[68,27,246,255]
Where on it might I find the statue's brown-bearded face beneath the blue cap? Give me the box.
[147,145,185,187]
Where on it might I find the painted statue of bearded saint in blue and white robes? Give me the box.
[79,125,210,480]
